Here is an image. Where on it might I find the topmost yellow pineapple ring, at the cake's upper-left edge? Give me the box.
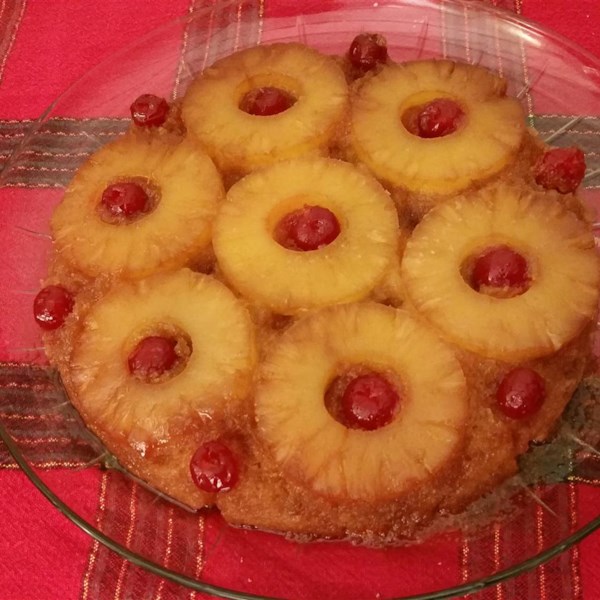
[182,44,348,172]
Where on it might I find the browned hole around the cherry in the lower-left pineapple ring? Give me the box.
[123,323,193,384]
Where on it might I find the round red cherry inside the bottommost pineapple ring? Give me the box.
[341,373,400,431]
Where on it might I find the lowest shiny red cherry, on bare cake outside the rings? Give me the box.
[190,440,239,494]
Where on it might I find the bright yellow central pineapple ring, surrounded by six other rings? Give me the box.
[213,158,398,314]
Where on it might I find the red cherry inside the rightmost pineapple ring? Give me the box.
[471,246,531,293]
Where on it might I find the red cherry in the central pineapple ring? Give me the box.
[274,206,340,251]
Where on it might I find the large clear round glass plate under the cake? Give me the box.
[0,0,600,600]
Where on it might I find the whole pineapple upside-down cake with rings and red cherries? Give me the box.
[34,34,600,544]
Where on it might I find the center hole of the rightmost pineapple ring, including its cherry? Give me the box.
[460,243,533,299]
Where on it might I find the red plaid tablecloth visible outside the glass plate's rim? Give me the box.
[0,0,600,600]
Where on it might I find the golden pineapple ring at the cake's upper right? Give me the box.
[350,60,525,194]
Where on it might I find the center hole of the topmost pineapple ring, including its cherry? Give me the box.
[235,73,302,117]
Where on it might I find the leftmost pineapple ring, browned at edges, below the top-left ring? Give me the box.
[51,136,224,279]
